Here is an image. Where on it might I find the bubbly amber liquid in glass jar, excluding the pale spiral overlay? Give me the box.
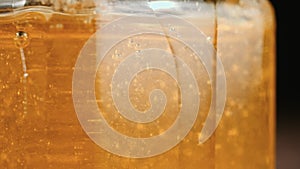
[0,1,275,169]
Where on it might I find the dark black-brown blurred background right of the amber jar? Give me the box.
[271,0,300,169]
